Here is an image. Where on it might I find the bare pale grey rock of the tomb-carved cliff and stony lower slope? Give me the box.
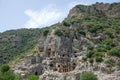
[13,27,120,80]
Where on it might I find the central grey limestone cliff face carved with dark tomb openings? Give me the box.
[42,30,76,73]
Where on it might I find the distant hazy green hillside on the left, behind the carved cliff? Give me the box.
[0,28,47,65]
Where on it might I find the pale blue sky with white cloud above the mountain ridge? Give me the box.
[0,0,120,32]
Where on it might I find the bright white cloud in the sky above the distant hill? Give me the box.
[24,5,64,28]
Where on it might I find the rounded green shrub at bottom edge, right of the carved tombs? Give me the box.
[80,72,98,80]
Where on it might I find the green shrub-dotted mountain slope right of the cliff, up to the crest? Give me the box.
[63,3,120,67]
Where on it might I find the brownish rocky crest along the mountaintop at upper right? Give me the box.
[68,2,120,18]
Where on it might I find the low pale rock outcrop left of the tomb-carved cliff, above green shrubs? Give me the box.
[12,55,44,78]
